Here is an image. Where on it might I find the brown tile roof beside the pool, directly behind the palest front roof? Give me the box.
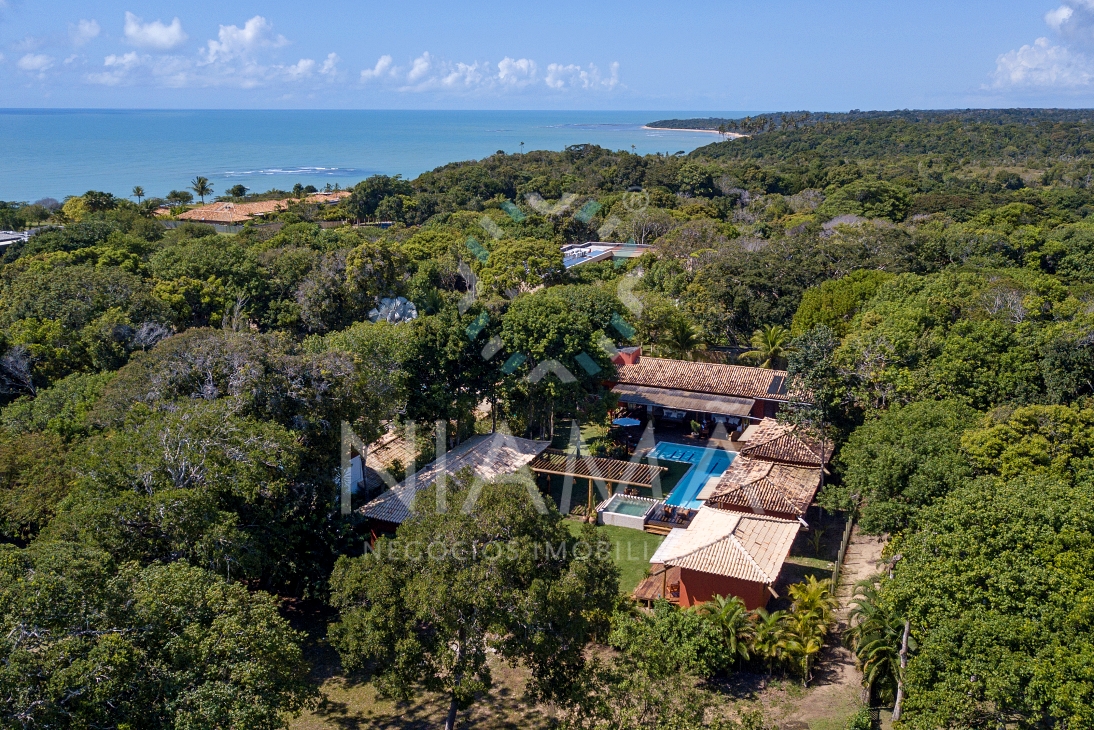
[707,455,821,515]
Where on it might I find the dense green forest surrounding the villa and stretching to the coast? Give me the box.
[0,109,1094,730]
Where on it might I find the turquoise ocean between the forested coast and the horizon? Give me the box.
[0,109,754,201]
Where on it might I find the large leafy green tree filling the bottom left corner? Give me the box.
[0,543,316,730]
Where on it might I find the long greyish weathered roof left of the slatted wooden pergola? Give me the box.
[359,432,550,524]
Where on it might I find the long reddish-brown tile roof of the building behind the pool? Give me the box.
[617,356,798,401]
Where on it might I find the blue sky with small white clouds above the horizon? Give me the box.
[0,0,1094,111]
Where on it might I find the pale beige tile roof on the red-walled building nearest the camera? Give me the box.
[650,507,799,584]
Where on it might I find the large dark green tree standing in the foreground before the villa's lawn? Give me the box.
[330,478,618,730]
